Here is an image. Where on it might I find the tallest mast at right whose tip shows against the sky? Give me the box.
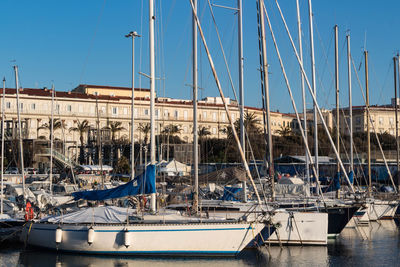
[334,25,340,198]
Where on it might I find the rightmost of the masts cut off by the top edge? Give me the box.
[308,0,319,179]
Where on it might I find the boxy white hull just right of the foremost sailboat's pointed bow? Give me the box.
[267,212,328,245]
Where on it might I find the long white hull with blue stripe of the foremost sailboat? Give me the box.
[21,222,265,256]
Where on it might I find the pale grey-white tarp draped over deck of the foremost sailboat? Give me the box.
[41,206,132,223]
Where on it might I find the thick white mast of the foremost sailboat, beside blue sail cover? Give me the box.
[149,0,156,212]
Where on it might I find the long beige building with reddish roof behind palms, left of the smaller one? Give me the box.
[0,85,294,151]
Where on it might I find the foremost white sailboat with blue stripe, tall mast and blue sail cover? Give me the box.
[21,0,269,256]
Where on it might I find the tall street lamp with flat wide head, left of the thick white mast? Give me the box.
[125,31,140,182]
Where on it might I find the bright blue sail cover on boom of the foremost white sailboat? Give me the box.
[72,165,156,200]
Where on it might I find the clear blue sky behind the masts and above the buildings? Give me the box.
[0,0,400,112]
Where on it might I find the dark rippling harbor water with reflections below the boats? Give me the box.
[0,220,400,267]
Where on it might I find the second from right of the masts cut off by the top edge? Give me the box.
[296,0,310,185]
